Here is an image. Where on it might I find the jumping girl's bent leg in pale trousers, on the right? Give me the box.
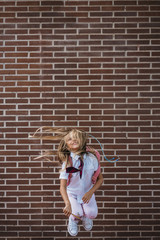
[83,194,98,219]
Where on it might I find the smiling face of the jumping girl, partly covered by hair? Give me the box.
[65,132,80,152]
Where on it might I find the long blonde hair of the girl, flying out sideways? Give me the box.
[30,126,95,166]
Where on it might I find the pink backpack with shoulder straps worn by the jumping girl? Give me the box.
[67,147,101,186]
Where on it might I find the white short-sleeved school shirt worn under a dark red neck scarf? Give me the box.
[59,152,98,203]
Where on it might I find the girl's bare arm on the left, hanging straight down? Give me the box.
[60,179,72,217]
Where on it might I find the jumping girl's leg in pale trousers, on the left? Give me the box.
[68,193,83,222]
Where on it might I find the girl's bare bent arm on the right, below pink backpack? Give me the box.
[82,173,103,203]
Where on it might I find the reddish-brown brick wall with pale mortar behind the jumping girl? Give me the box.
[0,0,160,240]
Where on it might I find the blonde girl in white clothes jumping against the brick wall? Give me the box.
[32,127,103,236]
